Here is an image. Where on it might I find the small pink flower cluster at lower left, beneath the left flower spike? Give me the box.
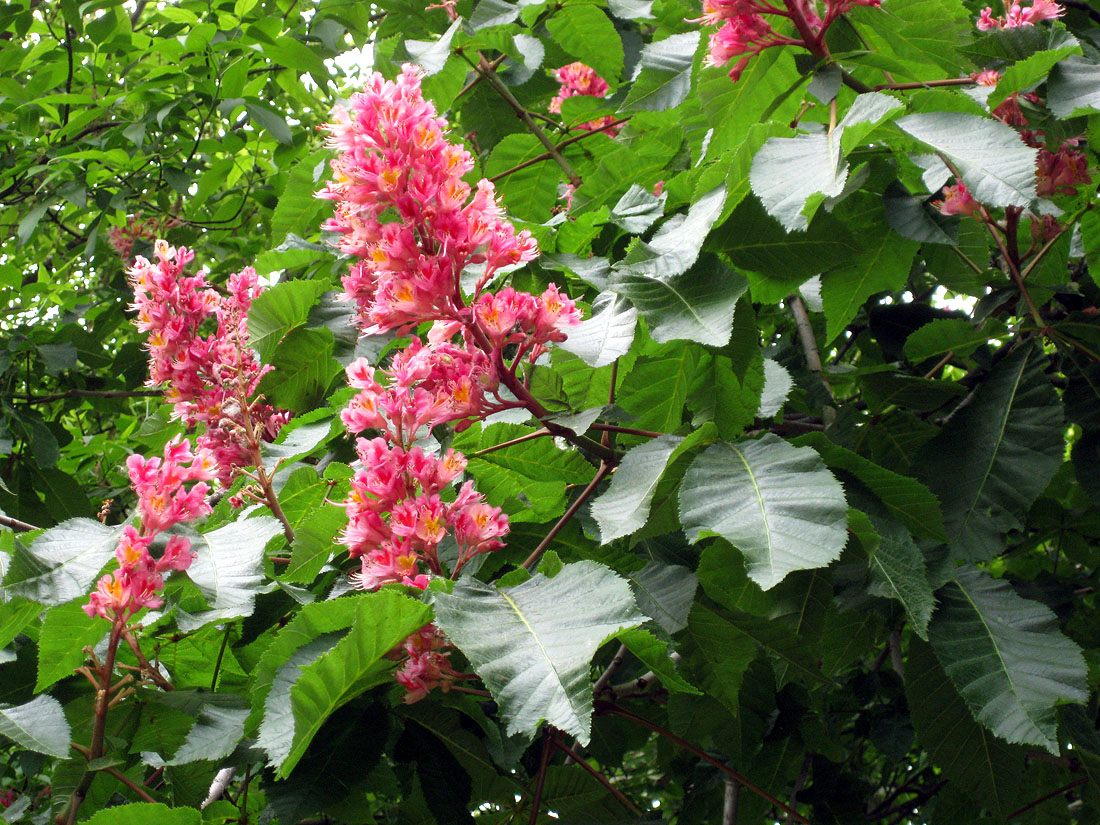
[84,439,216,622]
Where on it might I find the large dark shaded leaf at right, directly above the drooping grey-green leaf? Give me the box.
[920,347,1065,560]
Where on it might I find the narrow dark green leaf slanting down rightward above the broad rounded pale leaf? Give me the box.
[794,432,947,541]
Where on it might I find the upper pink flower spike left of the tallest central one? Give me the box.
[130,241,289,485]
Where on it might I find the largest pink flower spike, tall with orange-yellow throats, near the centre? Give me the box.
[318,65,585,702]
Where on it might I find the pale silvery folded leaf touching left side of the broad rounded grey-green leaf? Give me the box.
[592,436,683,545]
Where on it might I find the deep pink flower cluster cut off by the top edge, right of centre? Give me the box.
[688,0,882,80]
